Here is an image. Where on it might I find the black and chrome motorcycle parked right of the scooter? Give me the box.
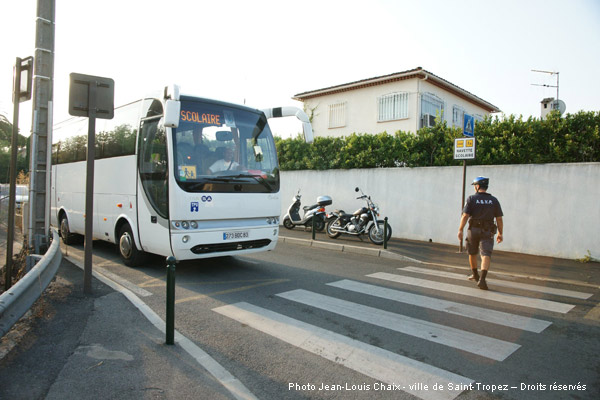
[327,188,392,245]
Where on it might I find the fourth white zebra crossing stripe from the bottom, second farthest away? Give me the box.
[367,272,575,314]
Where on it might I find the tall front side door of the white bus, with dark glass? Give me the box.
[137,117,173,255]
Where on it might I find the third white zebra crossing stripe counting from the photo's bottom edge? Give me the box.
[327,279,552,333]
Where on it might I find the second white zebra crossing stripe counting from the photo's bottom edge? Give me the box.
[277,289,521,361]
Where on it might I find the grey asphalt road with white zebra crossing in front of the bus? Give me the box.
[43,238,600,399]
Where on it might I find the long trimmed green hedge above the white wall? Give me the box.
[275,111,600,170]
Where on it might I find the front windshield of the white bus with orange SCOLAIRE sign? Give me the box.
[173,96,279,193]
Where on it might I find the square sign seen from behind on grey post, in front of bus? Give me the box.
[69,73,115,293]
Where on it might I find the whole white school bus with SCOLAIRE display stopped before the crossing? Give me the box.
[51,86,312,266]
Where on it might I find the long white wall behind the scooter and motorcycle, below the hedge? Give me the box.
[281,163,600,259]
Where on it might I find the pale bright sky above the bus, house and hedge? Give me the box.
[0,0,600,138]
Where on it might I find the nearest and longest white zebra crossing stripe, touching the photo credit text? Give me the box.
[213,302,474,400]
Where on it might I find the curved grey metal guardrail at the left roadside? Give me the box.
[0,228,62,337]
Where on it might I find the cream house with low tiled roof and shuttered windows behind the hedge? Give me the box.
[293,67,500,137]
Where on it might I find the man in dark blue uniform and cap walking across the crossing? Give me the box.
[458,176,504,290]
